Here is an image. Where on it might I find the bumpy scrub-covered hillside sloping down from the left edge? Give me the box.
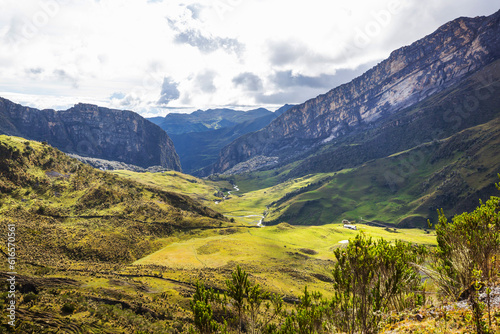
[0,136,226,263]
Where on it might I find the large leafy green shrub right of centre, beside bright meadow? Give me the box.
[330,233,426,333]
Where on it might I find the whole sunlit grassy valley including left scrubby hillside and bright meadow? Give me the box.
[0,136,436,333]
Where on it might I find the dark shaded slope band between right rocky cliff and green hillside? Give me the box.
[282,60,500,177]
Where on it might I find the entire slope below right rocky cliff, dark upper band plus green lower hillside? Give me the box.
[176,61,500,230]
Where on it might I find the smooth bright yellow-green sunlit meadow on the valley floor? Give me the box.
[134,224,436,298]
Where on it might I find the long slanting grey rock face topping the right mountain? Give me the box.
[210,11,500,172]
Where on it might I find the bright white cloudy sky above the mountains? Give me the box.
[0,0,500,116]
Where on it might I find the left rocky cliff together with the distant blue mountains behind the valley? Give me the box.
[0,98,292,172]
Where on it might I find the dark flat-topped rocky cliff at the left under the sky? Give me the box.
[0,98,181,171]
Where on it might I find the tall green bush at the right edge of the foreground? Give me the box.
[431,175,500,333]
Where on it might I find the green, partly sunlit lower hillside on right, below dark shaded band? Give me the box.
[179,118,500,227]
